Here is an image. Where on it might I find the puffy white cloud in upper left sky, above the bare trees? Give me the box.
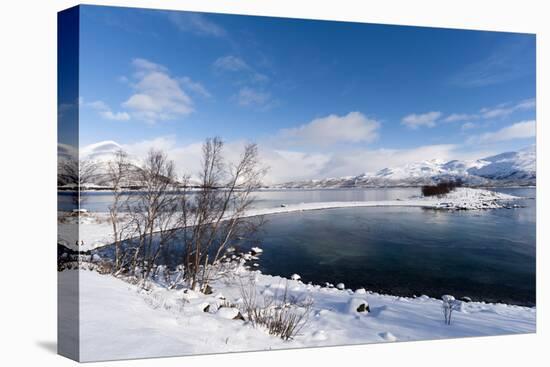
[123,59,193,123]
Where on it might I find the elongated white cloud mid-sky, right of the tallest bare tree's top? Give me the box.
[280,112,380,146]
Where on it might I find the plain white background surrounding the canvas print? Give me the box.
[0,0,550,367]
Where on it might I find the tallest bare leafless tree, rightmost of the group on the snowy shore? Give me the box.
[180,138,265,291]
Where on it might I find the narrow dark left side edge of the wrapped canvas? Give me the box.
[57,7,80,360]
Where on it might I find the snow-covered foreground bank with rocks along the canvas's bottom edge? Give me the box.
[63,269,536,361]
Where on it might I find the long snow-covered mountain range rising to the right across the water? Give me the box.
[277,146,536,188]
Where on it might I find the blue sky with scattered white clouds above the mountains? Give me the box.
[70,6,536,183]
